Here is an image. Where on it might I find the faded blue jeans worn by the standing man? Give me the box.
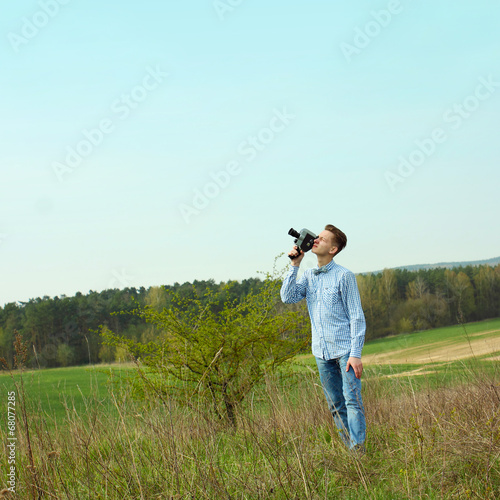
[316,355,366,448]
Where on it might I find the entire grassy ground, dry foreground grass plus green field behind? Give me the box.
[0,319,500,499]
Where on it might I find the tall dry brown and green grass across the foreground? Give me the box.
[1,364,500,500]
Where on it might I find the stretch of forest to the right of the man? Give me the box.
[357,265,500,340]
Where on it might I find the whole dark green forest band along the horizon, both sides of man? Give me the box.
[0,265,500,368]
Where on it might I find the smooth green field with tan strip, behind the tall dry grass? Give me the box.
[0,319,500,418]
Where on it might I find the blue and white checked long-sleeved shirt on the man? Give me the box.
[281,260,366,360]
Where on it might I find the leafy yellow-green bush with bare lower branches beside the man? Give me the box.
[101,277,309,425]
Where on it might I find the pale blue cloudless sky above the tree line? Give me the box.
[0,0,500,305]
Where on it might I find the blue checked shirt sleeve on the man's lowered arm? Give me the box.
[340,272,366,358]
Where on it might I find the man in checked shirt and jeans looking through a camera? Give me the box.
[281,224,366,452]
